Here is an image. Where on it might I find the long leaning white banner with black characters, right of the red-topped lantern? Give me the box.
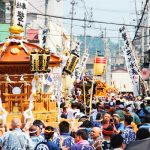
[120,26,141,96]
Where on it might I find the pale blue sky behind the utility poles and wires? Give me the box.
[64,0,145,40]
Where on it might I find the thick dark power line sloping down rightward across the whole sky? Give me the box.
[29,12,150,28]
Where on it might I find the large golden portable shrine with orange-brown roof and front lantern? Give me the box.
[0,26,61,122]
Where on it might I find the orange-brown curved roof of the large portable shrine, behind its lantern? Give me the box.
[0,40,62,64]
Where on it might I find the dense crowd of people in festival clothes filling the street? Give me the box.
[0,94,150,150]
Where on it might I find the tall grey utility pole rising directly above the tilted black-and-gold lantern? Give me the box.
[70,0,76,51]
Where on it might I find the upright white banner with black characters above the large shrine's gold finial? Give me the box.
[14,0,28,28]
